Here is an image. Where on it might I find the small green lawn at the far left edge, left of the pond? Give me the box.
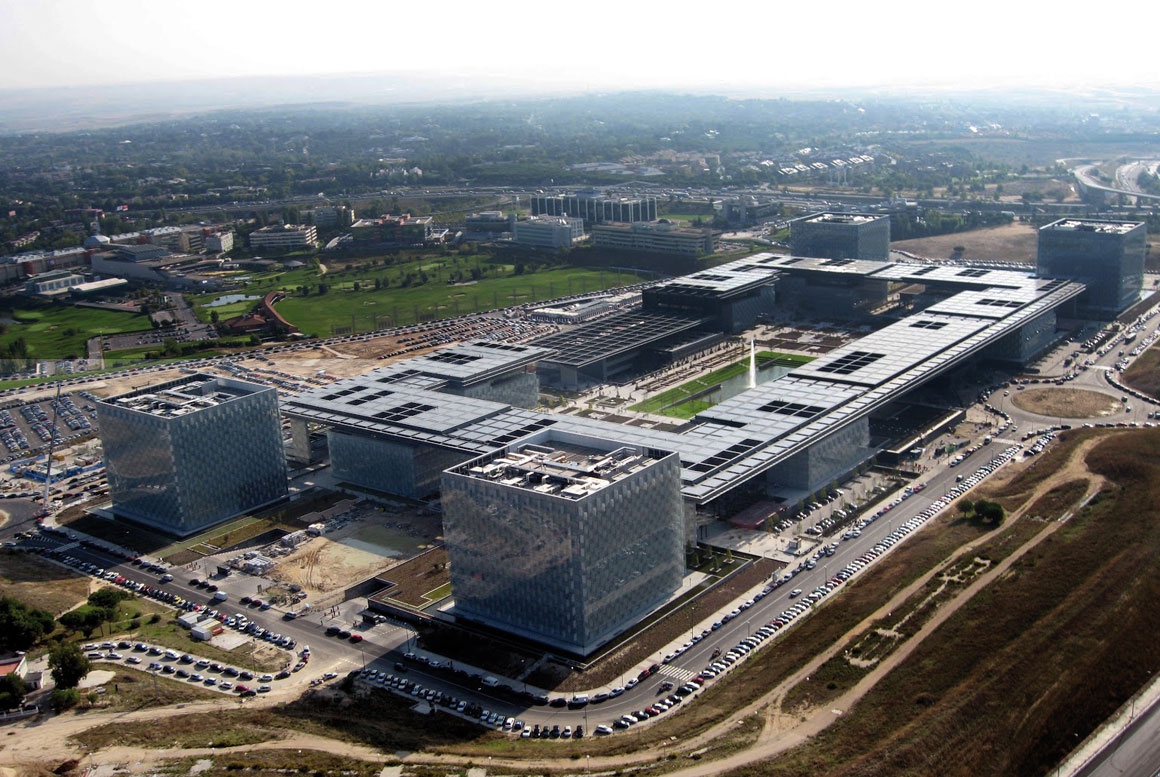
[0,299,152,360]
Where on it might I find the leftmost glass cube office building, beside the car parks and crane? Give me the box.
[95,375,287,536]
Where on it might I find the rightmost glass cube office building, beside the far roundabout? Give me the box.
[1036,218,1147,318]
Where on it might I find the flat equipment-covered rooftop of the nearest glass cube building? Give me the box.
[452,434,668,500]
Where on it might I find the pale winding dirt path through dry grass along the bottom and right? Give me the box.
[0,436,1105,777]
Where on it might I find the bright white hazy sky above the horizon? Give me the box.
[0,0,1160,90]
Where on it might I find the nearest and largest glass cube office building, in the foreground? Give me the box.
[442,430,684,655]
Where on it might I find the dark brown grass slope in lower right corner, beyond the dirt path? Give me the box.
[730,430,1160,776]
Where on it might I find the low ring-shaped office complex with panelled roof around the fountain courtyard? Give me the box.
[283,253,1085,510]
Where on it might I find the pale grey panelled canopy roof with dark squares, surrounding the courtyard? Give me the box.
[283,254,1085,502]
